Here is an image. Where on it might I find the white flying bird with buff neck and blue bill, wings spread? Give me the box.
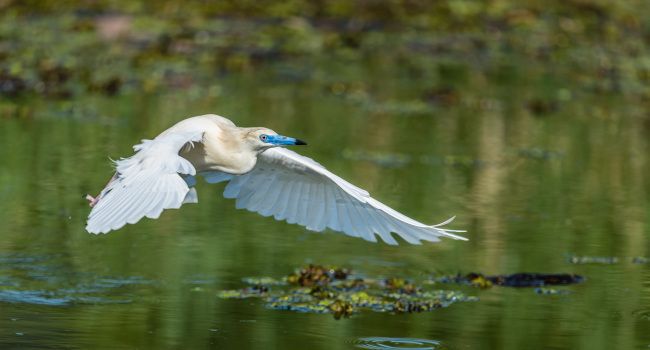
[86,114,466,244]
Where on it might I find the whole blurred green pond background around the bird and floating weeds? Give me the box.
[0,0,650,349]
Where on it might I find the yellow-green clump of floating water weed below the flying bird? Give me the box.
[217,265,478,319]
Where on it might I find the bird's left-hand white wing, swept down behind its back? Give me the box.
[86,130,203,234]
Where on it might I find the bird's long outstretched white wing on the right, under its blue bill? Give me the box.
[220,148,466,244]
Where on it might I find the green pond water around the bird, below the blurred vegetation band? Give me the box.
[0,60,650,349]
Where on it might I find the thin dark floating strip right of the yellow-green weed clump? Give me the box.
[437,272,584,288]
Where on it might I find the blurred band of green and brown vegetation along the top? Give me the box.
[0,0,650,113]
